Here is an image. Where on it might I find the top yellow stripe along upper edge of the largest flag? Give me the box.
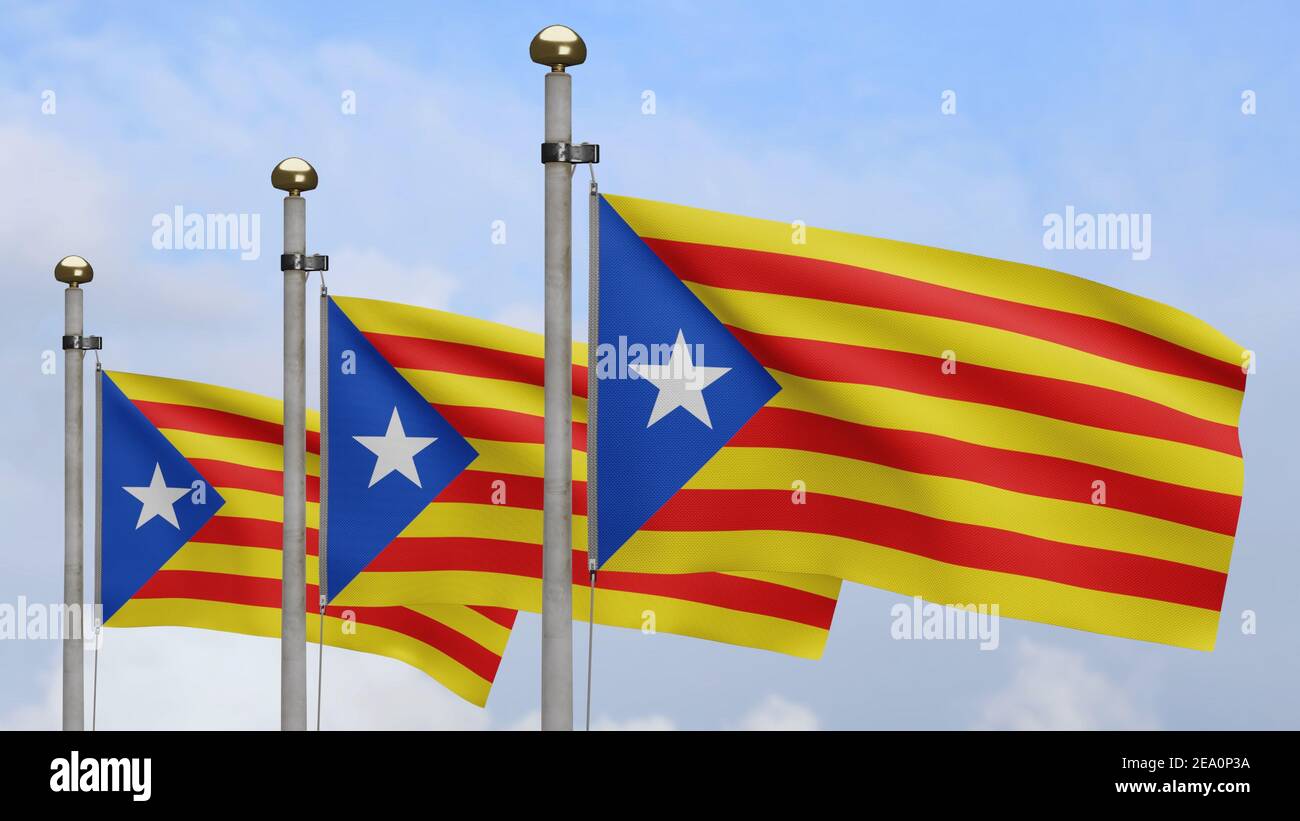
[606,195,1243,365]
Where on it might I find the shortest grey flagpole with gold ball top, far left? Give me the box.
[55,256,100,730]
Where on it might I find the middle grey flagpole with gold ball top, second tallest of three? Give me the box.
[270,157,322,730]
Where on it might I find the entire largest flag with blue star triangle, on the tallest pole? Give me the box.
[595,196,1249,650]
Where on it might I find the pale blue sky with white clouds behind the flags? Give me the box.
[0,3,1300,727]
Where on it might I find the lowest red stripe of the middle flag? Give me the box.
[365,537,835,630]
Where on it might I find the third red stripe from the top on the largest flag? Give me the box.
[727,408,1242,535]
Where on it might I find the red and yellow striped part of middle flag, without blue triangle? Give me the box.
[332,297,840,659]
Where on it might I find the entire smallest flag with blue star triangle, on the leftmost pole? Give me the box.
[99,373,515,705]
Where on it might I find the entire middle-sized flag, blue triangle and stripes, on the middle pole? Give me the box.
[326,296,840,659]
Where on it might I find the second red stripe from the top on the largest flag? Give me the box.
[731,327,1242,456]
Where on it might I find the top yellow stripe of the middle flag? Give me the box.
[334,296,586,362]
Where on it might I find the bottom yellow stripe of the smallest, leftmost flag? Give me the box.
[111,599,491,707]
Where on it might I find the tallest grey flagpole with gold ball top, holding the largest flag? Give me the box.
[528,26,595,730]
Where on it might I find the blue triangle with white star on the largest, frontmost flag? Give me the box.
[595,197,781,565]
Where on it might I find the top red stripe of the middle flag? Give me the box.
[365,333,586,398]
